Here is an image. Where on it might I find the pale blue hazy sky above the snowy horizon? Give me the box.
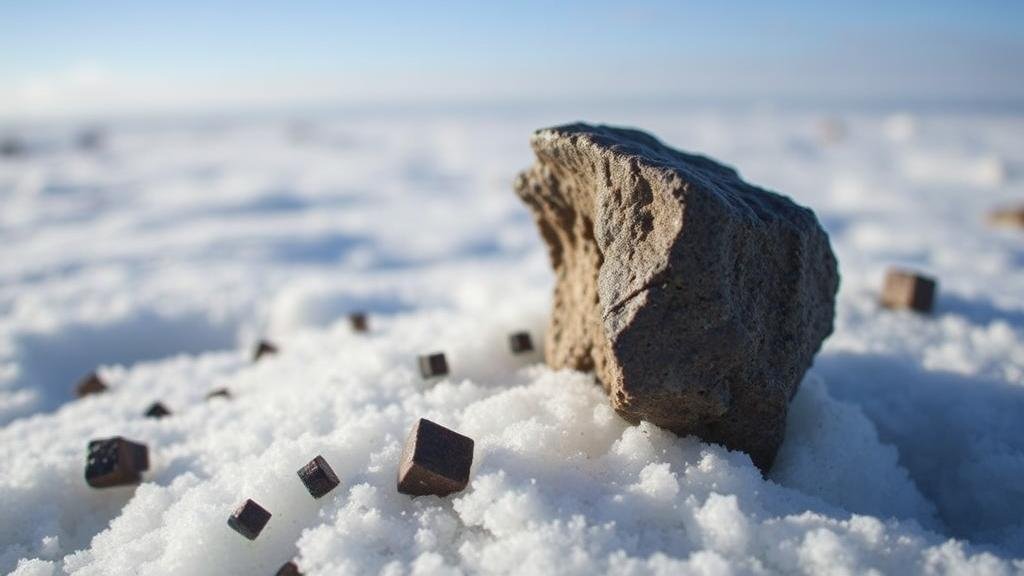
[0,0,1024,115]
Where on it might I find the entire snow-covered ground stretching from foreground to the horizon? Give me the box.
[0,101,1024,575]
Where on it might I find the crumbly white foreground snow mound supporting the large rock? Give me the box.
[0,311,1010,574]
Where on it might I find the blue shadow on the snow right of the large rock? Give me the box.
[815,353,1024,556]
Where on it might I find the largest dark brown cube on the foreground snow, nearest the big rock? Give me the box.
[398,418,473,496]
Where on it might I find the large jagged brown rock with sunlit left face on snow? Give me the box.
[516,124,839,470]
